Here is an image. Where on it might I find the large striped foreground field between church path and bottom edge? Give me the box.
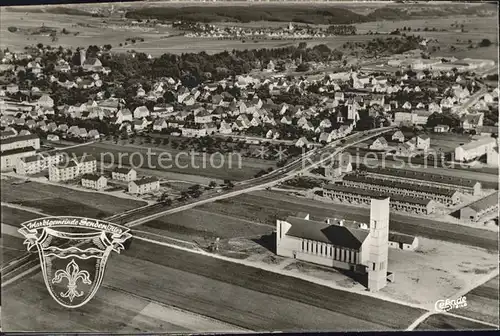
[2,240,422,332]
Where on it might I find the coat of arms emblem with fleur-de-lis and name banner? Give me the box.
[19,216,131,308]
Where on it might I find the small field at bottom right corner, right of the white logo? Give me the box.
[453,275,499,324]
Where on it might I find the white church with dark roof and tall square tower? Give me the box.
[276,197,393,292]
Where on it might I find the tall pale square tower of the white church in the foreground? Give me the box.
[368,197,390,292]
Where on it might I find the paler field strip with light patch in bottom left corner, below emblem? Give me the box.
[3,274,238,333]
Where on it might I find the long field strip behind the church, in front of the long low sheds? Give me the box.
[198,191,498,251]
